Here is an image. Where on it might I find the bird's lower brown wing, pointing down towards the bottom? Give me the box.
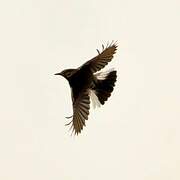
[68,90,90,135]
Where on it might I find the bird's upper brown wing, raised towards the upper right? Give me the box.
[81,41,117,73]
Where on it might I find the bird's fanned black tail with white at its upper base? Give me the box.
[95,70,117,104]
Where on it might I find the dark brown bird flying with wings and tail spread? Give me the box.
[54,41,118,135]
